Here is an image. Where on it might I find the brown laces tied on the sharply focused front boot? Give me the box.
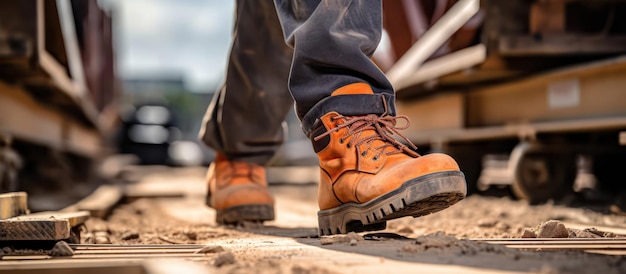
[313,114,419,160]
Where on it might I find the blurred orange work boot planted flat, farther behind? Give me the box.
[206,153,274,224]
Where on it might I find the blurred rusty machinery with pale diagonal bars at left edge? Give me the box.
[0,0,119,201]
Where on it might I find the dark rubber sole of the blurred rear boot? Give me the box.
[215,204,274,225]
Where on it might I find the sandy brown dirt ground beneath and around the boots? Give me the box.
[82,169,626,273]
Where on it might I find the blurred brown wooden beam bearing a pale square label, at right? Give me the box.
[467,56,626,127]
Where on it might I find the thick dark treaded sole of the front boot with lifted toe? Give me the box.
[317,171,467,236]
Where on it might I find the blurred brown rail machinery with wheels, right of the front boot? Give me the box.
[376,0,626,202]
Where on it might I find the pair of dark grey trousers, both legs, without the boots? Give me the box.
[201,0,395,164]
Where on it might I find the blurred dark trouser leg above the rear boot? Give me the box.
[200,1,293,165]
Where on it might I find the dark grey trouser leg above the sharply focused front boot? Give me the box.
[275,0,395,134]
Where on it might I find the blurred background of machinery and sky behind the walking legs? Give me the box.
[0,0,626,210]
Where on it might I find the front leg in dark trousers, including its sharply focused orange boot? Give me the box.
[276,0,466,235]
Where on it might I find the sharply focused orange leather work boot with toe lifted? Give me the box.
[311,84,467,235]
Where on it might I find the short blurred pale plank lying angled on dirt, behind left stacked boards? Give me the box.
[75,185,123,218]
